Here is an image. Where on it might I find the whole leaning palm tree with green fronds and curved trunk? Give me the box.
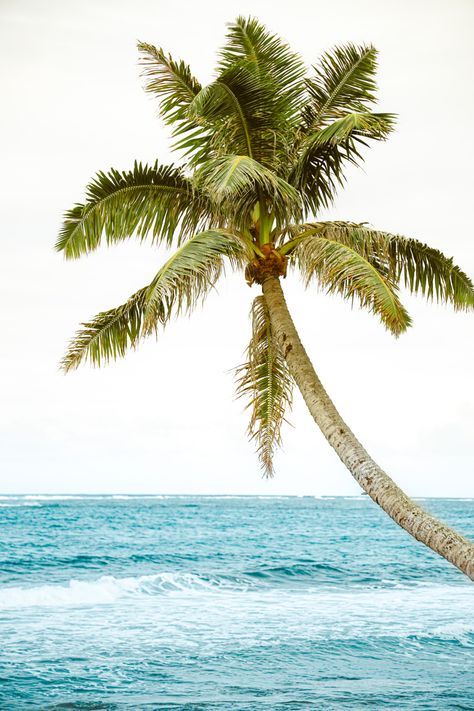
[56,17,474,579]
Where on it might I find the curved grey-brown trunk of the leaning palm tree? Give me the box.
[262,277,474,580]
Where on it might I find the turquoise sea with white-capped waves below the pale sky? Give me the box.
[0,496,474,711]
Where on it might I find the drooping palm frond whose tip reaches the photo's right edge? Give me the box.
[292,222,474,309]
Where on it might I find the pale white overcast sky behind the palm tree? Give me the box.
[0,0,474,497]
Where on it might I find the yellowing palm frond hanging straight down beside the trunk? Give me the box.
[236,296,293,476]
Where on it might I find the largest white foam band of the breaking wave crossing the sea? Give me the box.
[0,571,474,624]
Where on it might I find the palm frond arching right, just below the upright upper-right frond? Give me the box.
[288,112,395,213]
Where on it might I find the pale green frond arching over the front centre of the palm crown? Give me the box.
[195,155,301,226]
